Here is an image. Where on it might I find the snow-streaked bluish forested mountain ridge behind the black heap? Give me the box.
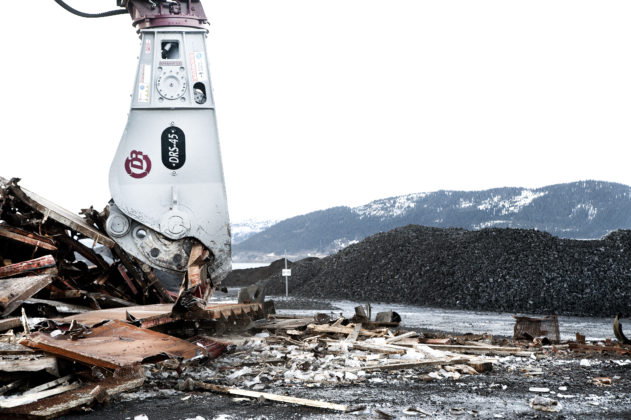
[234,181,631,259]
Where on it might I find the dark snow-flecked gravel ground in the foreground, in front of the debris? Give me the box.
[58,348,631,420]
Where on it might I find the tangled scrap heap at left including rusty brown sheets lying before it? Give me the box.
[0,178,273,418]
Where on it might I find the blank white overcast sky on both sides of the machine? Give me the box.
[0,0,631,221]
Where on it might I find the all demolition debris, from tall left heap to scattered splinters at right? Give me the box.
[0,179,631,419]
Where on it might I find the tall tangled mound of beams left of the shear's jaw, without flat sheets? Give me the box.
[0,178,176,317]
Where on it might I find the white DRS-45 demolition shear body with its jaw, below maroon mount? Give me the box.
[106,27,231,282]
